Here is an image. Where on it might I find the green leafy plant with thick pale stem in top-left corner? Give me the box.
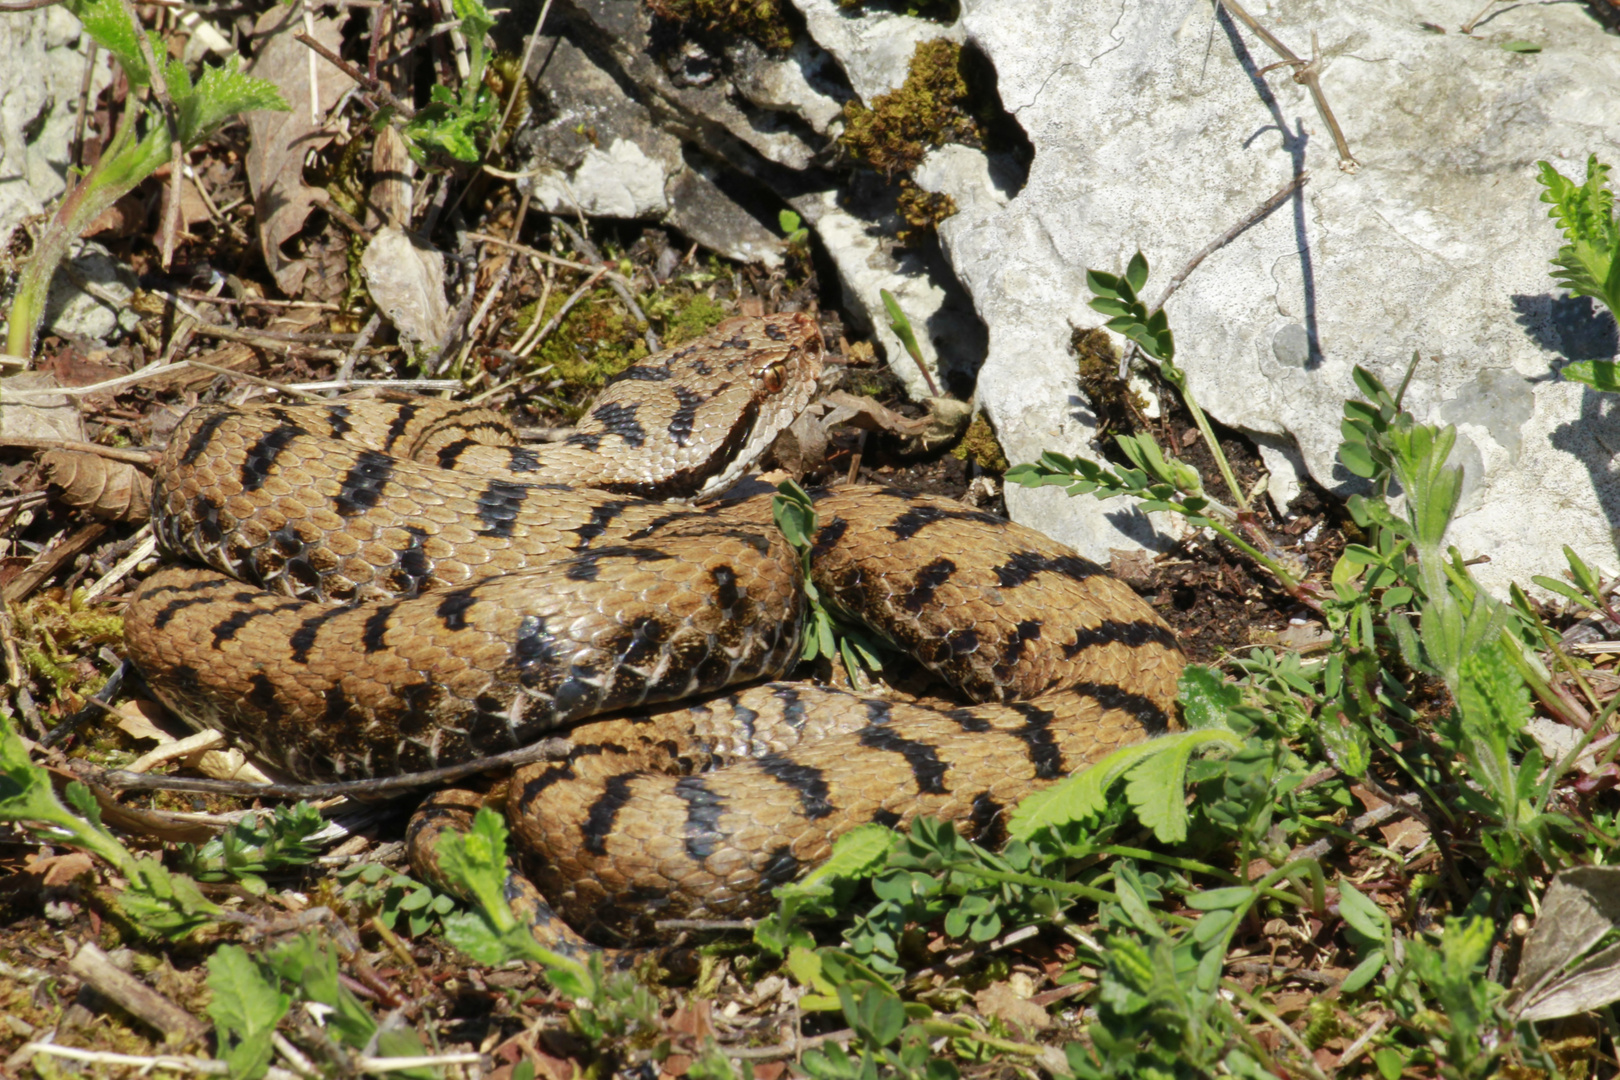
[6,0,287,358]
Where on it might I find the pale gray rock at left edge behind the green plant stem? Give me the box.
[0,5,112,251]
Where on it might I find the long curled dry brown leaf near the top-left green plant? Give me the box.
[246,5,353,296]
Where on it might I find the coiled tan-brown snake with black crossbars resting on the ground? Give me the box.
[126,314,1183,944]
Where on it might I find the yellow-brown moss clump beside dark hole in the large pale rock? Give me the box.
[839,39,982,176]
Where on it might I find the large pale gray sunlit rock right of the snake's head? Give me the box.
[933,0,1620,588]
